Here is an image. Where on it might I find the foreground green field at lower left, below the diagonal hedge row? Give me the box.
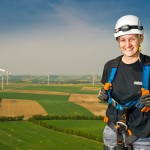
[0,121,103,150]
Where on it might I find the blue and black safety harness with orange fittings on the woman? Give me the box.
[104,54,150,150]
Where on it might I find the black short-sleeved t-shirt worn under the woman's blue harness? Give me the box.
[101,54,150,138]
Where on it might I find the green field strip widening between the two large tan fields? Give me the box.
[0,92,93,116]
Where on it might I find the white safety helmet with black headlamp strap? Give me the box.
[114,15,144,38]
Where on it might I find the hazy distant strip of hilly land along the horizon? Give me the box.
[0,75,101,85]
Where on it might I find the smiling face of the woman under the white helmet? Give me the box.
[118,34,144,57]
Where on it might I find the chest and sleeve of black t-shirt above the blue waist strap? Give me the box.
[101,56,143,104]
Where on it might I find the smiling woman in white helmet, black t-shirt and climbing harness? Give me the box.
[98,15,150,150]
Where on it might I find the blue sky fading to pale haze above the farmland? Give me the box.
[0,0,150,75]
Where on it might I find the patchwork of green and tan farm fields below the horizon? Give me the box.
[0,84,107,150]
